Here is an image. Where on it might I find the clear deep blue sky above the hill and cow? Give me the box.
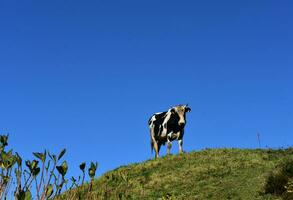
[0,0,293,177]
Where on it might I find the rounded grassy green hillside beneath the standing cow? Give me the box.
[61,149,293,200]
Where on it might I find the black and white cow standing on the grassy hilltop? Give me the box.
[149,105,191,158]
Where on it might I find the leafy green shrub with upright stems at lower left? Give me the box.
[0,135,98,200]
